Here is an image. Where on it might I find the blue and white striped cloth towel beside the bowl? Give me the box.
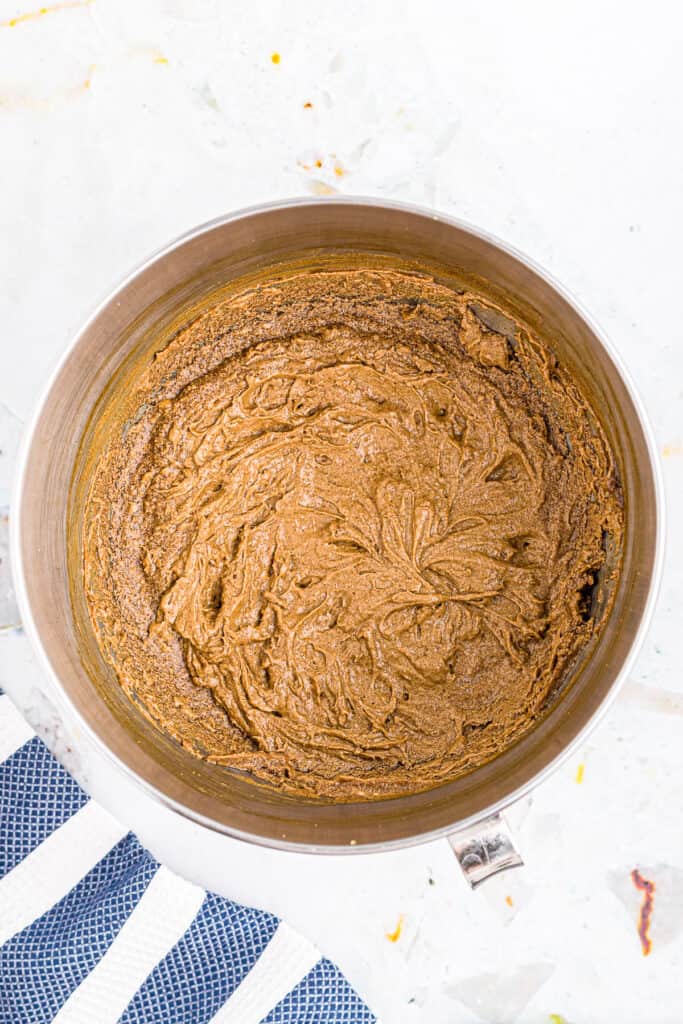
[0,693,375,1024]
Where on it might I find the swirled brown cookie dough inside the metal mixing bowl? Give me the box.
[84,268,623,801]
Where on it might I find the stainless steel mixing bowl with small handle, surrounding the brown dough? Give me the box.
[12,199,663,873]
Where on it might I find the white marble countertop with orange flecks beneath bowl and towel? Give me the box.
[0,0,683,1024]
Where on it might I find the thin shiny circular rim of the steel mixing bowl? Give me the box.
[10,196,666,854]
